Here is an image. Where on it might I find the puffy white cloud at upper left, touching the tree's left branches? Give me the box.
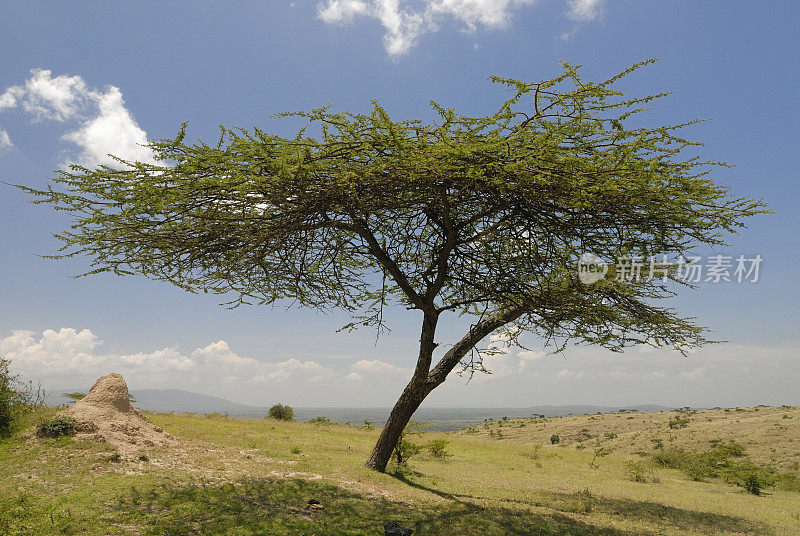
[0,69,156,167]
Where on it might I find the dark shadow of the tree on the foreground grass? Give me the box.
[108,479,664,536]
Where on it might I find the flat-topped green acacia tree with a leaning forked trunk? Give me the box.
[27,62,762,471]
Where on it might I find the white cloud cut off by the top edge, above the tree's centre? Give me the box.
[317,0,534,57]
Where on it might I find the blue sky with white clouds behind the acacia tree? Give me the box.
[0,0,800,406]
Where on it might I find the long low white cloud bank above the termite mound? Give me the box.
[0,328,333,386]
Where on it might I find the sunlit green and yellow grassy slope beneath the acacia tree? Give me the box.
[0,408,800,536]
